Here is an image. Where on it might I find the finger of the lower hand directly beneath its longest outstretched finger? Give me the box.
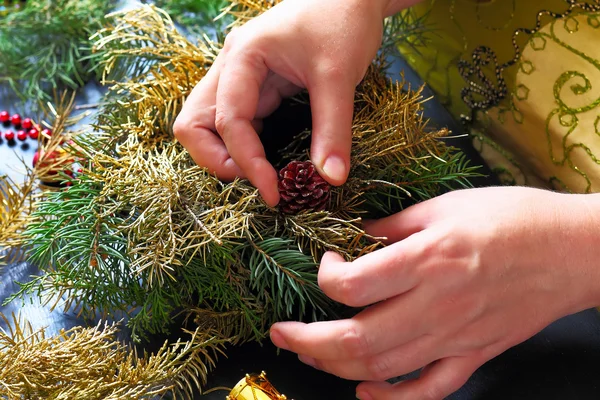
[299,335,441,382]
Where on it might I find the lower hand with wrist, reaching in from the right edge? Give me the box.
[271,187,600,400]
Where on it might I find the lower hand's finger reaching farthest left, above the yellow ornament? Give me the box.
[271,290,435,361]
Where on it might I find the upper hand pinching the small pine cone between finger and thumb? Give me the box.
[174,0,416,206]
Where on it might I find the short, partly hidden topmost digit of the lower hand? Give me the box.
[364,201,434,244]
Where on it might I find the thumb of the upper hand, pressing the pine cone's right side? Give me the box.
[308,69,356,186]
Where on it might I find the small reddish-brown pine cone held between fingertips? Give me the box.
[279,161,331,214]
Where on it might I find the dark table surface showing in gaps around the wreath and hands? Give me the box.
[0,32,600,400]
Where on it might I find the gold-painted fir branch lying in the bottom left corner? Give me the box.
[0,315,229,400]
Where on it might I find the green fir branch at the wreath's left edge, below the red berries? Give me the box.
[7,177,144,316]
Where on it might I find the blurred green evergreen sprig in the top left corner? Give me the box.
[0,0,111,101]
